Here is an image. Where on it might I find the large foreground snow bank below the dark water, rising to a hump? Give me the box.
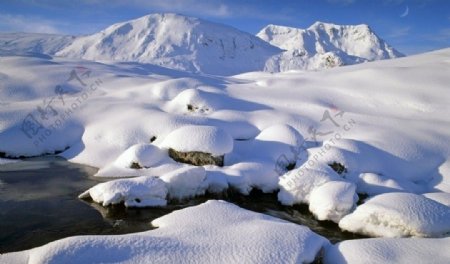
[0,200,328,263]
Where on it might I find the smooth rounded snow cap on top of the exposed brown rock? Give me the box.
[161,125,233,156]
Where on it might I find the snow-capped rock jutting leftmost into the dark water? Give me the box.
[79,176,167,207]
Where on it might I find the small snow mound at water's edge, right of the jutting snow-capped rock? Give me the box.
[160,166,208,199]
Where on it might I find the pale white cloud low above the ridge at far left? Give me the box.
[0,13,60,34]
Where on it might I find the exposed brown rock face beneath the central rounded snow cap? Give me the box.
[169,148,224,167]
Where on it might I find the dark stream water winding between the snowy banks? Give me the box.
[0,158,366,253]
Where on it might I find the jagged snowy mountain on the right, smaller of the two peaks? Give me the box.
[257,22,403,71]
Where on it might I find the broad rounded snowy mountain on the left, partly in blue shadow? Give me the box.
[56,14,280,75]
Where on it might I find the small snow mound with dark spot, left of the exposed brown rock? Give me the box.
[114,144,167,168]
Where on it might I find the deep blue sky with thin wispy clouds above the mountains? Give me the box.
[0,0,450,55]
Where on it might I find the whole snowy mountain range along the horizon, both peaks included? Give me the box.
[0,13,403,76]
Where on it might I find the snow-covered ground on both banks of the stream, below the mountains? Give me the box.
[0,13,450,262]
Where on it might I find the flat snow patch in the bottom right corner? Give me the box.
[323,237,450,264]
